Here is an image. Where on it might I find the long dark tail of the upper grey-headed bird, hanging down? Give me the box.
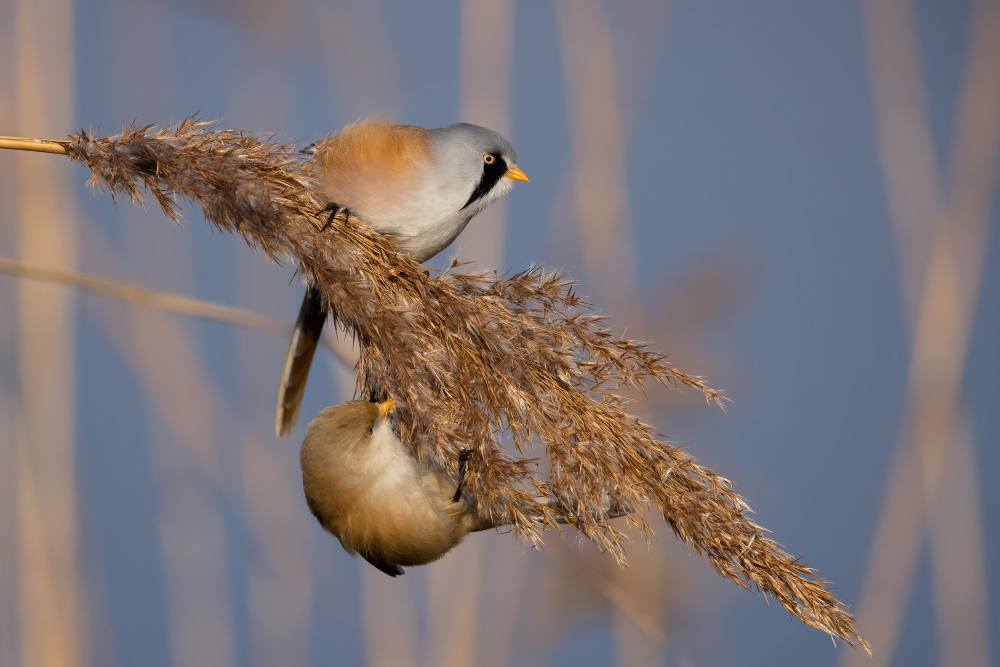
[275,285,326,438]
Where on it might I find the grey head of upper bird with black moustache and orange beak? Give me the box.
[429,123,528,217]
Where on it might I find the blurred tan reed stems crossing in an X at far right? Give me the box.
[841,0,1000,666]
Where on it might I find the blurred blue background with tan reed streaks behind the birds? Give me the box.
[0,0,1000,667]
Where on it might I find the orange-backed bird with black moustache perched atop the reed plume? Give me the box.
[275,119,528,437]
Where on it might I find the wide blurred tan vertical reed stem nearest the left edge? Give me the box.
[8,0,89,667]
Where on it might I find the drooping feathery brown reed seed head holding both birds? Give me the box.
[3,118,870,653]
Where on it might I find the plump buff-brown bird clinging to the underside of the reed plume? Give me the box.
[299,400,494,577]
